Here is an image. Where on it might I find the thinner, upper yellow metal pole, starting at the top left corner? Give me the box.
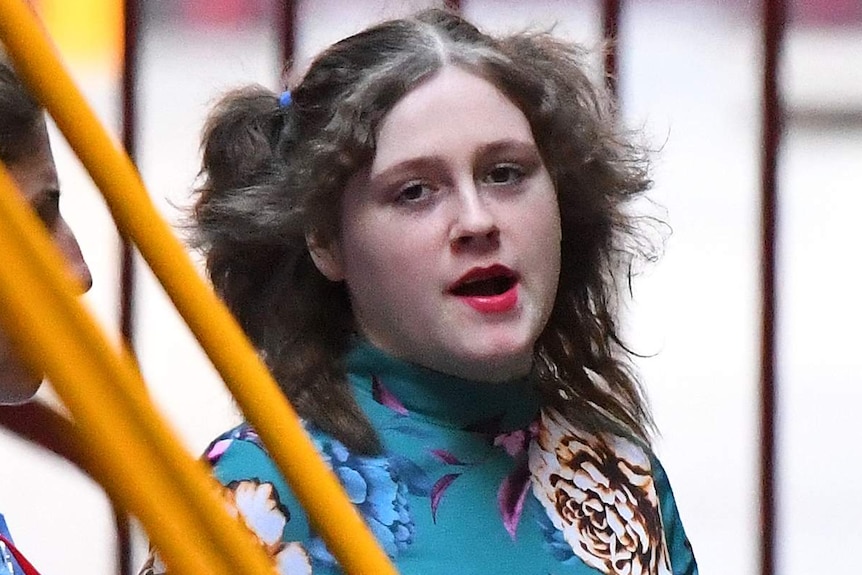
[0,0,397,575]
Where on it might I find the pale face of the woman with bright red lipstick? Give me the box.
[312,66,561,381]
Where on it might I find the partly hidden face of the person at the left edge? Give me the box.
[0,118,93,403]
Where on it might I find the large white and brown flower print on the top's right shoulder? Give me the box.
[530,412,671,575]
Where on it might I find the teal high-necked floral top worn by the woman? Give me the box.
[140,344,697,575]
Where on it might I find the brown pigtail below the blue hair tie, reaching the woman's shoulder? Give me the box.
[192,86,380,453]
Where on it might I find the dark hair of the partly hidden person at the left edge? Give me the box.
[0,59,45,164]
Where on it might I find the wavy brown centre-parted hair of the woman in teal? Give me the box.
[193,6,652,452]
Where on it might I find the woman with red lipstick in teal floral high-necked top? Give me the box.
[145,10,697,575]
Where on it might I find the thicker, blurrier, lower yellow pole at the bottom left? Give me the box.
[0,163,273,575]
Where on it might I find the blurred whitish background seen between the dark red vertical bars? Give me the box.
[0,0,862,575]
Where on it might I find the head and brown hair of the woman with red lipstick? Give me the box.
[195,6,660,452]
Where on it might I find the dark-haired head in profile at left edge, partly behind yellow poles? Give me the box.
[0,60,92,403]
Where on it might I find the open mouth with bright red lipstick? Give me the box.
[449,265,518,313]
